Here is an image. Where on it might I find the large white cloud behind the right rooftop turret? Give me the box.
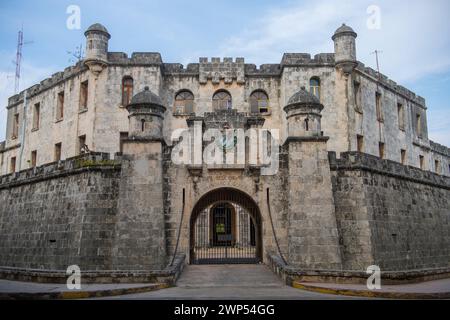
[216,0,450,83]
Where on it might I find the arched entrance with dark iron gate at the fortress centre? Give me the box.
[190,188,262,264]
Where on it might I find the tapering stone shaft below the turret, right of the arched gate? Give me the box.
[288,137,342,270]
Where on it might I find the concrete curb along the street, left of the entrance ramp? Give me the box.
[0,284,171,300]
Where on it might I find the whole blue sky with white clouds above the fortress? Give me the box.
[0,0,450,146]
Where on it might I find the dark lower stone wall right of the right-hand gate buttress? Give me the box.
[330,152,450,270]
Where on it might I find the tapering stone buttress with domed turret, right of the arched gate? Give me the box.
[284,88,342,270]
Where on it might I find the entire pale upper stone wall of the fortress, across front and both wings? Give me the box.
[0,53,450,179]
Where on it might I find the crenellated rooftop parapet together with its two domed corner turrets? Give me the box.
[8,23,426,109]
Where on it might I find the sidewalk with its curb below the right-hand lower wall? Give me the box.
[293,279,450,299]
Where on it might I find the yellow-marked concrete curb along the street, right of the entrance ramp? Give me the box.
[292,281,450,300]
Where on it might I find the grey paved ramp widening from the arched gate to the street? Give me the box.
[100,265,356,300]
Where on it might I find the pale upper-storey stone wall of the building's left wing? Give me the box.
[0,64,90,175]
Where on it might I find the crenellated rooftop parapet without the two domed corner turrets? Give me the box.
[7,52,426,109]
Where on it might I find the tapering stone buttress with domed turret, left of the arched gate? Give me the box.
[113,87,167,270]
